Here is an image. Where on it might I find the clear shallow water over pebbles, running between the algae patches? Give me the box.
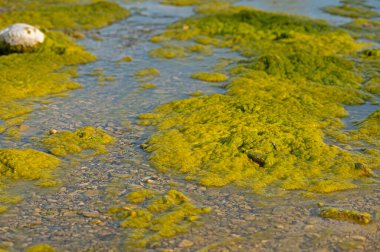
[0,0,380,251]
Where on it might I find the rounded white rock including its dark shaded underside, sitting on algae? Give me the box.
[0,23,45,54]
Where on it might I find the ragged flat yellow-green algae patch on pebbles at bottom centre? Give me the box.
[109,189,211,249]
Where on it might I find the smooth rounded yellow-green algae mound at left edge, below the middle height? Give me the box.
[0,149,60,179]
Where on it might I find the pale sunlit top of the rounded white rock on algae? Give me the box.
[0,24,45,47]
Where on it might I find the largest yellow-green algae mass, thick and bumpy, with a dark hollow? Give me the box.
[140,7,378,193]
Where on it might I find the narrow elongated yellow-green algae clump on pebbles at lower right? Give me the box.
[320,207,371,224]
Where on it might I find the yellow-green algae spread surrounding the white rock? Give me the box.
[0,1,129,135]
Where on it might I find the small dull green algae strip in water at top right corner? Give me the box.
[322,4,380,18]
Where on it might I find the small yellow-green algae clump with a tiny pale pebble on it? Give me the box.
[41,126,114,157]
